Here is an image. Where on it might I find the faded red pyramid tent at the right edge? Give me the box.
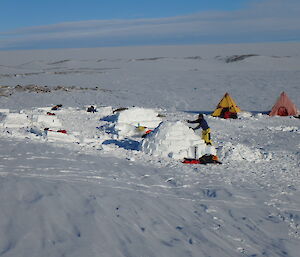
[269,92,298,116]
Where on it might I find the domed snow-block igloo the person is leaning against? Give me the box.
[140,121,216,160]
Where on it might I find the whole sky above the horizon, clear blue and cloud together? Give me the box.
[0,0,300,50]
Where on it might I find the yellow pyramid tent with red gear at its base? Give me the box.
[212,93,241,119]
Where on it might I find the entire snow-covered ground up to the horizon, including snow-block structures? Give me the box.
[0,43,300,257]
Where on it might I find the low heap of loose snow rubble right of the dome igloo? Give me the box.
[218,142,265,162]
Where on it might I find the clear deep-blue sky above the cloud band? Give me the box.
[0,0,251,31]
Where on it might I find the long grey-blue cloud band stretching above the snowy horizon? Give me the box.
[0,0,300,49]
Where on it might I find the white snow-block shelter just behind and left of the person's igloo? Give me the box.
[115,107,162,137]
